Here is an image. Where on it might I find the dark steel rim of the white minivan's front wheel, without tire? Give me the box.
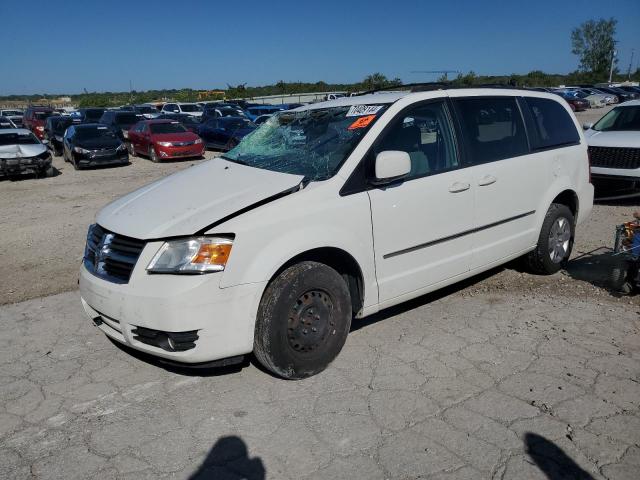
[287,290,336,353]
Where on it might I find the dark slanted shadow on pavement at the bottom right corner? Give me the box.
[524,432,594,480]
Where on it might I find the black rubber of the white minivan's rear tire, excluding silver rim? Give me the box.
[524,203,576,275]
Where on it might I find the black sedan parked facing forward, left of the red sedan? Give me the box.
[62,123,129,170]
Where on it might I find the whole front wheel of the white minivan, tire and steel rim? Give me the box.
[254,262,352,379]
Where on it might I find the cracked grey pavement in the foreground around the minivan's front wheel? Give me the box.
[0,280,640,480]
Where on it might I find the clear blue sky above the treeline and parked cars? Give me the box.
[0,0,640,95]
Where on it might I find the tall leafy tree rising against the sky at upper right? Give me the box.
[571,18,618,75]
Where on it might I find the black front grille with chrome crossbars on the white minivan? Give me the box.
[84,224,145,283]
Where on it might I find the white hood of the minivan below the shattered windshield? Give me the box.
[97,158,303,240]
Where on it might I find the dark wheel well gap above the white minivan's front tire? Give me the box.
[269,247,364,315]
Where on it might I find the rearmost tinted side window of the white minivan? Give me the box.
[525,97,580,149]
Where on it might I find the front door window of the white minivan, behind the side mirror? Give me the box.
[374,102,460,179]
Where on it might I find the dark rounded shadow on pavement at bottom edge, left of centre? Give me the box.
[189,436,267,480]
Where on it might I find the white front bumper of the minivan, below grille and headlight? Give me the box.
[80,242,266,364]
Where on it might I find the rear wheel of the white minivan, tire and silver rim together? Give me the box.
[525,203,575,275]
